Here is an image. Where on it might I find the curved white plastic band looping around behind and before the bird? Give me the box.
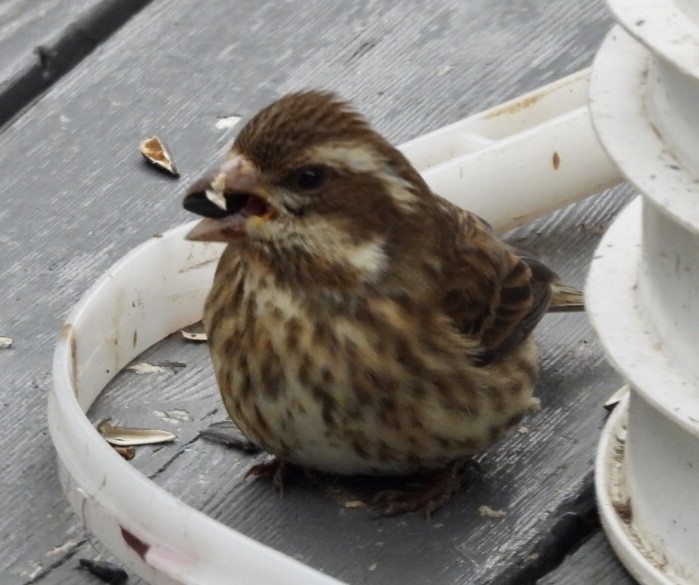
[48,71,620,585]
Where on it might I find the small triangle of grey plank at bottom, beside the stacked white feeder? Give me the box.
[538,532,636,585]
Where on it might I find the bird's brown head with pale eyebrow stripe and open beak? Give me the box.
[184,91,429,286]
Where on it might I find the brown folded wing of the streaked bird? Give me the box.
[439,201,555,364]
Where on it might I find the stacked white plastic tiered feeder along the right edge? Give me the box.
[587,0,699,585]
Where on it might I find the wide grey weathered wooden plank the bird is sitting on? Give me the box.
[0,0,628,585]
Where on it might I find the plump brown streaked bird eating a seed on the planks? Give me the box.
[184,91,582,515]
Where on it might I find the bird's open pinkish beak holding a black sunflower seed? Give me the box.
[182,153,276,242]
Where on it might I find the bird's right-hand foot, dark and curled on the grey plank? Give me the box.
[371,462,464,518]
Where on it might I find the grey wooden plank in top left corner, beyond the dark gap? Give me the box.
[0,0,150,125]
